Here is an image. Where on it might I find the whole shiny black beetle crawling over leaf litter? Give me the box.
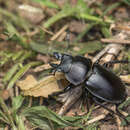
[50,52,128,123]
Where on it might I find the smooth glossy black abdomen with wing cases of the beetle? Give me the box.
[86,64,126,104]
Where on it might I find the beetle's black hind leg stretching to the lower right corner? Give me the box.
[93,97,129,125]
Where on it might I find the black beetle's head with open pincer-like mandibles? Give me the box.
[50,52,73,73]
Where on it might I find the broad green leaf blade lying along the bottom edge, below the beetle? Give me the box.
[22,106,82,127]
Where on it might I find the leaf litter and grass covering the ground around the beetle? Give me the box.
[0,0,129,130]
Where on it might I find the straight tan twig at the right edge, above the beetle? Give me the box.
[101,38,130,44]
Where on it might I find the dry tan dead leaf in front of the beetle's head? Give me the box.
[17,73,67,97]
